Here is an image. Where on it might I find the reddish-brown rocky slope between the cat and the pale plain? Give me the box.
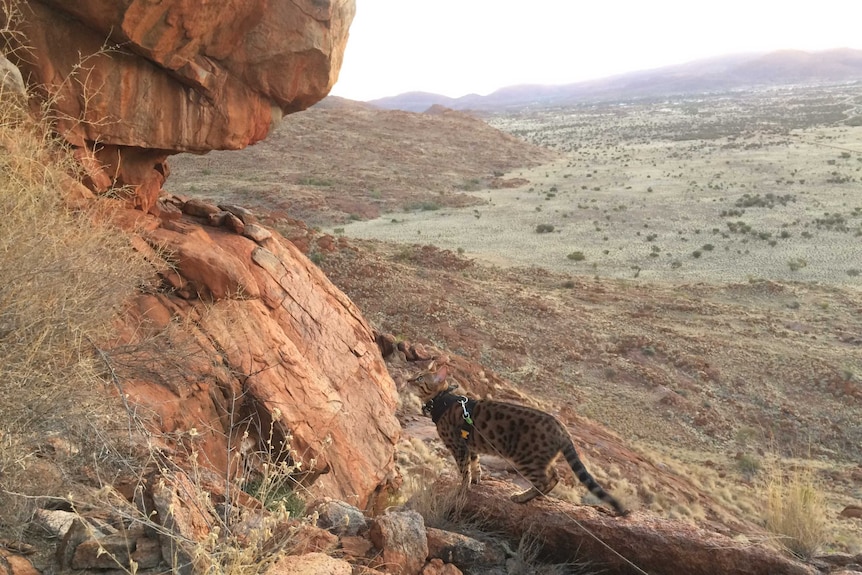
[320,234,862,546]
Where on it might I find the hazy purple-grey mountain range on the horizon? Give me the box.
[368,49,862,112]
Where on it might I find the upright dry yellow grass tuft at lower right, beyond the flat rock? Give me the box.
[766,468,827,558]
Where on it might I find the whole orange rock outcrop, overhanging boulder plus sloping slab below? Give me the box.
[0,0,400,507]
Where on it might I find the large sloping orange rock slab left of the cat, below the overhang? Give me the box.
[110,199,400,508]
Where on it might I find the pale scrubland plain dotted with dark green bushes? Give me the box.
[340,86,862,285]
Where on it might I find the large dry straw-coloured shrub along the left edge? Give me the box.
[0,62,152,528]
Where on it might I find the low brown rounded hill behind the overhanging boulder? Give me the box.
[169,102,558,225]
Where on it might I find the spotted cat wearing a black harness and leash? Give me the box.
[410,364,627,515]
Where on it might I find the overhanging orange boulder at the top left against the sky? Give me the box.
[6,0,355,211]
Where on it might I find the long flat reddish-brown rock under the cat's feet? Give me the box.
[460,480,816,575]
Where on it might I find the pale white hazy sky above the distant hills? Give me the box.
[332,0,862,100]
